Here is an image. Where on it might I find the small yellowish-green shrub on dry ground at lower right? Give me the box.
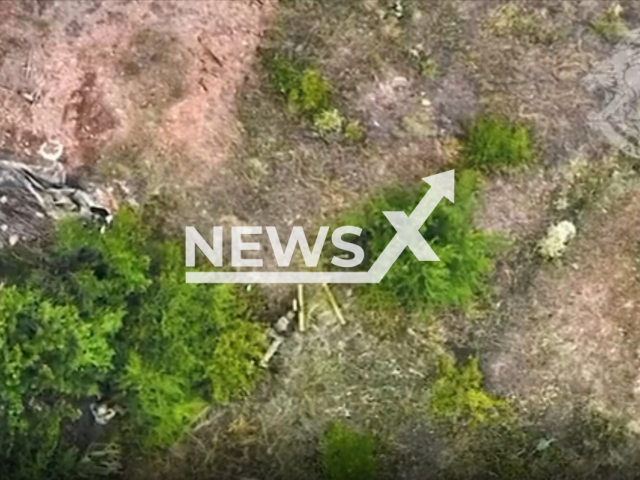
[429,357,507,426]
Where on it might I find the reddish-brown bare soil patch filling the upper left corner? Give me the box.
[0,0,273,178]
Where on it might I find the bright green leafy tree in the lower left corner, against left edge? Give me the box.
[0,287,109,479]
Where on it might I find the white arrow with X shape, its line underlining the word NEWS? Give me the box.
[186,170,455,284]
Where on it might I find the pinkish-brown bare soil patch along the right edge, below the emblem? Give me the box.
[488,170,640,421]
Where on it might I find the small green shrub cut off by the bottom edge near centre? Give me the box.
[320,422,378,480]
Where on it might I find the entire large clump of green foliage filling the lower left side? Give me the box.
[0,209,264,478]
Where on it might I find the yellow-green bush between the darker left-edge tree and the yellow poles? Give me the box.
[54,210,263,445]
